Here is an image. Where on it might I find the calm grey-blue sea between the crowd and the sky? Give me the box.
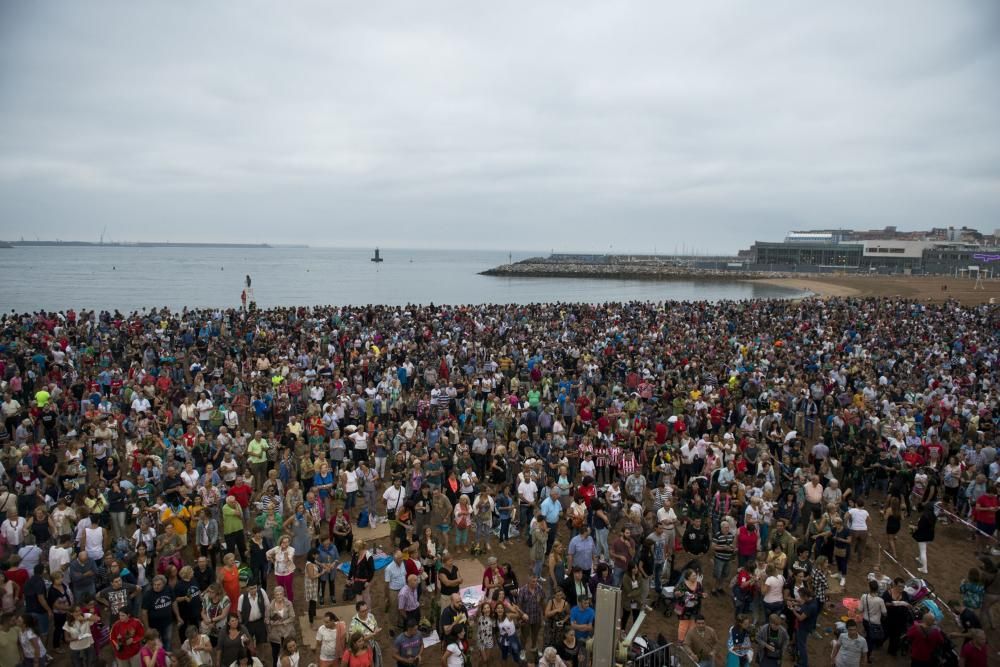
[0,246,805,312]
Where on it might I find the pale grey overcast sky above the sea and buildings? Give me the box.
[0,0,1000,252]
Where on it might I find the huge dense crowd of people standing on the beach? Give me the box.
[0,298,1000,667]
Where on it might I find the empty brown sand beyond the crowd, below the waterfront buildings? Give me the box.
[747,276,1000,306]
